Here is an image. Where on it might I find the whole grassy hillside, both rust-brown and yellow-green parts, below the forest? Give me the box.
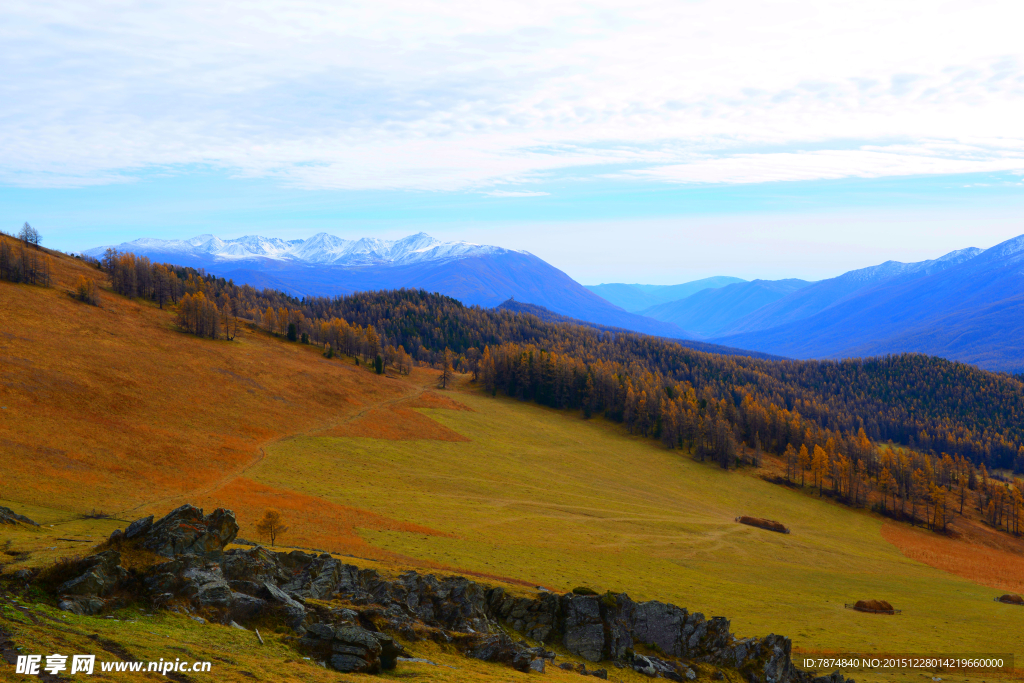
[0,246,1024,681]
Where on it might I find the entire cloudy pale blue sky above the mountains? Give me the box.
[0,0,1024,284]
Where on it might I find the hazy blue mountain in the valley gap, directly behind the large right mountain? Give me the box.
[641,280,811,337]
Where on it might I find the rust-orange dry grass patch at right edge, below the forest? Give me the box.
[882,521,1024,592]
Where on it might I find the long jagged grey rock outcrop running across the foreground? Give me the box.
[44,506,845,683]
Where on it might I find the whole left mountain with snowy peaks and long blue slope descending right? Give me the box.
[85,232,693,339]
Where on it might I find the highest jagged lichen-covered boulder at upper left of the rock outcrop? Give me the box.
[138,505,239,557]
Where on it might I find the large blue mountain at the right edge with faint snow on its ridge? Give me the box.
[715,236,1024,372]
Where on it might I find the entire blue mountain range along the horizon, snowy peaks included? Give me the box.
[86,232,1024,372]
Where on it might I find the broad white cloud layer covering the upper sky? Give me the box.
[6,0,1024,187]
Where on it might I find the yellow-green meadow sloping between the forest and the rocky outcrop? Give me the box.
[250,391,1024,680]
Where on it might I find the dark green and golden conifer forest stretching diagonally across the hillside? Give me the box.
[70,250,1024,532]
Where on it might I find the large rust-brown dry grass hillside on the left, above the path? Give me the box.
[0,240,419,514]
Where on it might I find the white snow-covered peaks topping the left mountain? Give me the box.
[85,232,525,266]
